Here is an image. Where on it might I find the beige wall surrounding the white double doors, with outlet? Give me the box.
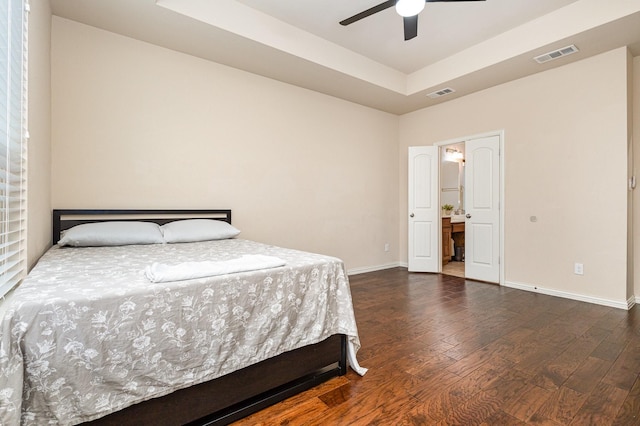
[399,48,630,304]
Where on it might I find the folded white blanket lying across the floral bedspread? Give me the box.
[144,254,286,283]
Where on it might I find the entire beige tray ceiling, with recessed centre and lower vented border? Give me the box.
[51,0,640,114]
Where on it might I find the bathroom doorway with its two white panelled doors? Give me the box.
[408,131,504,284]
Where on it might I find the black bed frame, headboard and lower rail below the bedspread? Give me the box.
[53,209,347,426]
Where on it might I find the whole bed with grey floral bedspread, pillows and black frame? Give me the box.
[0,210,366,425]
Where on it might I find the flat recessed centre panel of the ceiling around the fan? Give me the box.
[238,0,576,74]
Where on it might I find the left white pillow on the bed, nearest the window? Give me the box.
[58,221,164,247]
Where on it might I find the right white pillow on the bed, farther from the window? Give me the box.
[161,219,240,243]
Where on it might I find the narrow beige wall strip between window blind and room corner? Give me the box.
[27,1,51,268]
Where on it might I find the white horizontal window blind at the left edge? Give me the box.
[0,0,28,297]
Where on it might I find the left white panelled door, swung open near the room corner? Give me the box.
[408,146,442,272]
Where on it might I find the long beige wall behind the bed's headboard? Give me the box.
[52,17,399,270]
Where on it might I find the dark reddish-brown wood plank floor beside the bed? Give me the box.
[236,268,640,426]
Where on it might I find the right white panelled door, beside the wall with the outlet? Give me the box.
[464,136,500,283]
